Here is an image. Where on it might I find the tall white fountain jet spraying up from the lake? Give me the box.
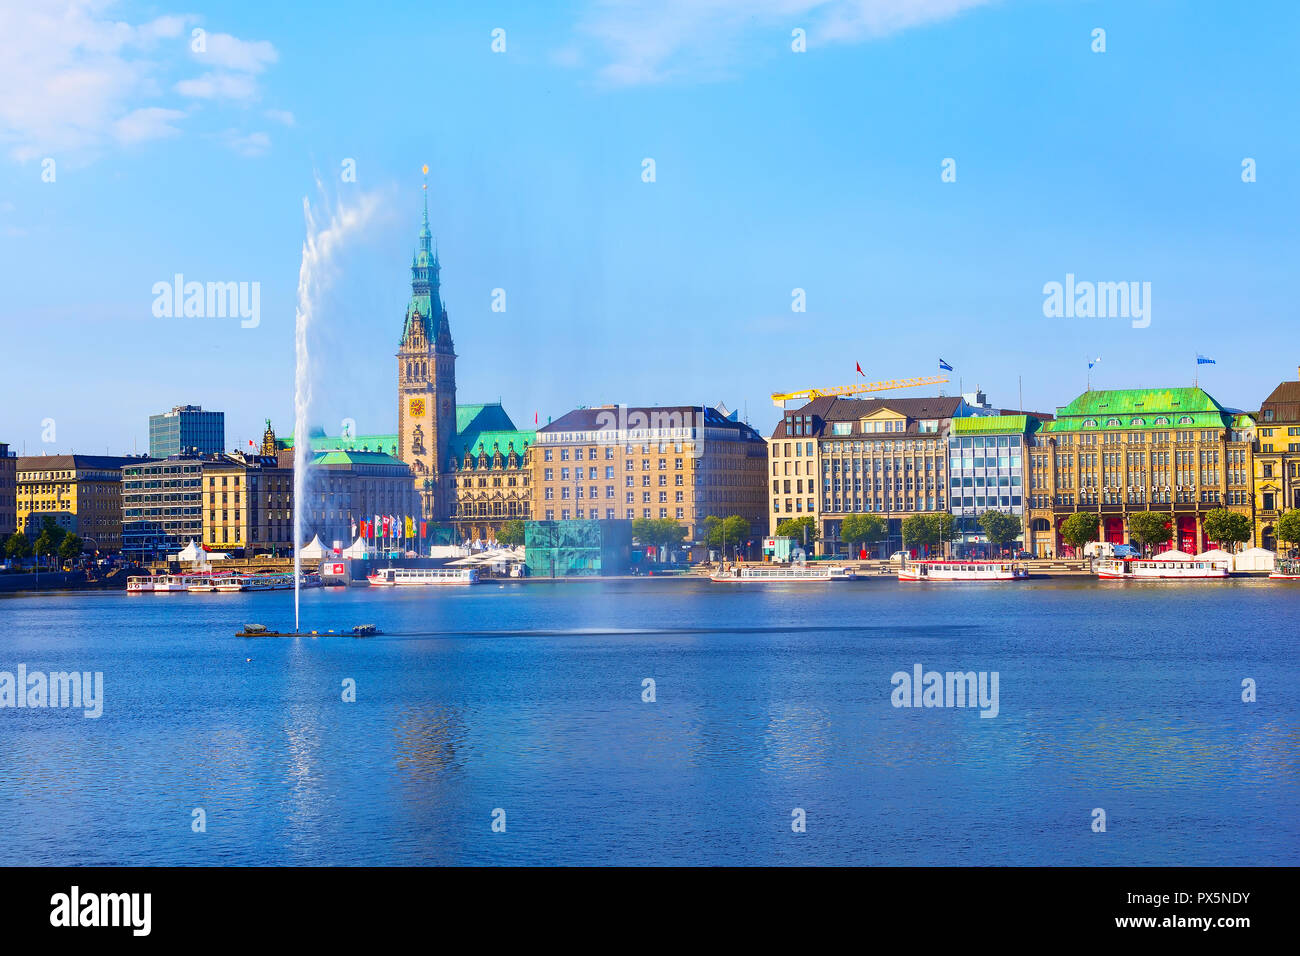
[294,189,378,633]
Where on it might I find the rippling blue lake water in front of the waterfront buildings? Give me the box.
[0,580,1300,865]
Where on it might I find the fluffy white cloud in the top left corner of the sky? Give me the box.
[0,0,277,161]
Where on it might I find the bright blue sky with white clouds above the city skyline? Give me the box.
[0,0,1300,454]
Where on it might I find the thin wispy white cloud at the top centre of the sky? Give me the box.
[560,0,995,85]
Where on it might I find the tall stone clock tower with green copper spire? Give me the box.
[398,186,456,522]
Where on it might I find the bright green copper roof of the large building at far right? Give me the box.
[1047,388,1232,432]
